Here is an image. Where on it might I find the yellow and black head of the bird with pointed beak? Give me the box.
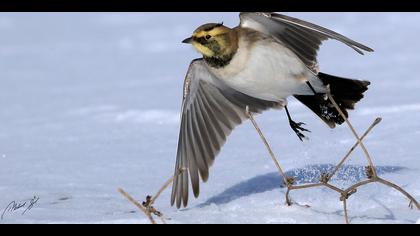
[182,23,238,58]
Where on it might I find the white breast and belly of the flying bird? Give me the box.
[208,36,310,101]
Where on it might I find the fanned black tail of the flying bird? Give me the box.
[295,73,370,128]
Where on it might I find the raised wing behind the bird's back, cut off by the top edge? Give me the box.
[240,12,373,72]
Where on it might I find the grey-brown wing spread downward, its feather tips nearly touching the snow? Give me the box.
[171,59,281,208]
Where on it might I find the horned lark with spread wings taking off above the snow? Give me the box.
[171,13,373,208]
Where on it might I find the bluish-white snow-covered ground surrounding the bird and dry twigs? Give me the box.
[0,13,420,224]
